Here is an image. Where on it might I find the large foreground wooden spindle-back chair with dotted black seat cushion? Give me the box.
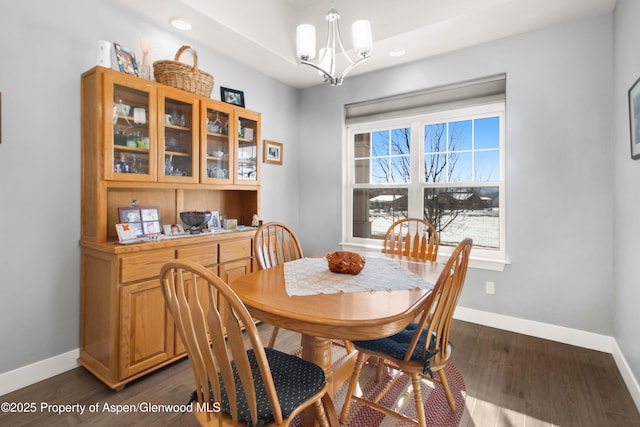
[160,261,338,427]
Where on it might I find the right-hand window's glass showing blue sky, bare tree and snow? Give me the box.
[423,118,499,248]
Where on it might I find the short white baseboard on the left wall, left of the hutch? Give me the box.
[0,349,80,396]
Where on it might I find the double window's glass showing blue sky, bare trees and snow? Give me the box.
[352,112,500,249]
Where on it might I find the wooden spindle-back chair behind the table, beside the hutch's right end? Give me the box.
[253,222,304,348]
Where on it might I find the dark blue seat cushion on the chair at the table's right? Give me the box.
[353,323,437,375]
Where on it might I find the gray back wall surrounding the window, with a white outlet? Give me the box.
[300,15,614,335]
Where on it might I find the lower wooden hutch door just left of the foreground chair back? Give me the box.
[120,279,174,379]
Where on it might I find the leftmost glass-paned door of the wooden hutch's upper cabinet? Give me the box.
[103,76,156,181]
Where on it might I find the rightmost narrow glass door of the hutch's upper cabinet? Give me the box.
[235,110,260,184]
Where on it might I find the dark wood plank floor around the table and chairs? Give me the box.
[0,321,640,427]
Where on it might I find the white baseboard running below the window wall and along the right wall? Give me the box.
[453,306,640,411]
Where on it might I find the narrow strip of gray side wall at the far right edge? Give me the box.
[609,0,640,378]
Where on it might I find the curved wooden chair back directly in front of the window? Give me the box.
[382,218,440,261]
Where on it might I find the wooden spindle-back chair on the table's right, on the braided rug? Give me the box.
[340,239,473,427]
